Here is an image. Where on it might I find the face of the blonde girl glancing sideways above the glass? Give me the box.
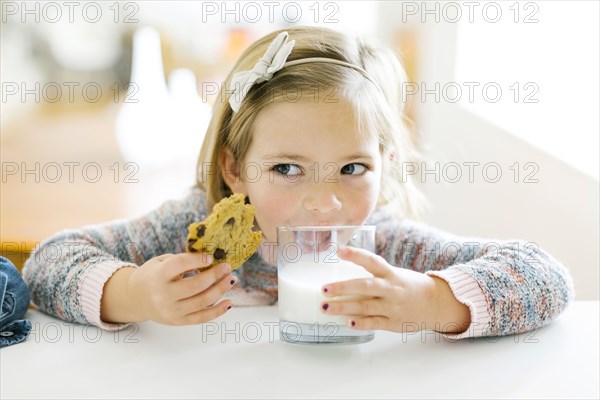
[223,100,382,242]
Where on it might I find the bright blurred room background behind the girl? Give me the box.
[0,1,600,300]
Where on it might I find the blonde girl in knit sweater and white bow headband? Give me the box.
[24,28,574,338]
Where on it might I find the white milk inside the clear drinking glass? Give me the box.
[278,257,373,325]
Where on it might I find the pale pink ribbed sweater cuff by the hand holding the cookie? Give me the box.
[78,261,137,331]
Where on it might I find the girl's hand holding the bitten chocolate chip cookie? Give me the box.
[127,253,237,325]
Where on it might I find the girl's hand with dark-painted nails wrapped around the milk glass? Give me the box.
[321,247,470,333]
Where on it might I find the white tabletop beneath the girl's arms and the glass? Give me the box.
[0,301,600,399]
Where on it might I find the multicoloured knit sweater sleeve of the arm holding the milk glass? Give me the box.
[371,211,575,339]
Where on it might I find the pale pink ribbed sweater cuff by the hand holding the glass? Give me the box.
[426,268,491,339]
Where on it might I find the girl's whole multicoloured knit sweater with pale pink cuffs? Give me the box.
[23,189,574,339]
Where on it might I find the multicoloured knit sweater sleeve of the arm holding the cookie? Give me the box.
[23,189,206,330]
